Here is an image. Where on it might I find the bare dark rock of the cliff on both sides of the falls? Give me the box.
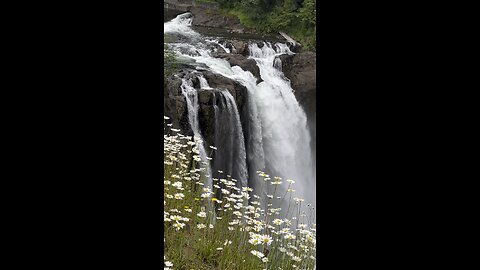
[164,40,317,161]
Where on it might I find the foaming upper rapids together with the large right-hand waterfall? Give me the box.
[164,14,316,209]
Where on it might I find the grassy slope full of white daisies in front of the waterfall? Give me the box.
[164,117,316,270]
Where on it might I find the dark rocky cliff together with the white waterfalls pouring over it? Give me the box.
[164,6,316,206]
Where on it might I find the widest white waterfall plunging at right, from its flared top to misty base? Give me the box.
[249,43,316,208]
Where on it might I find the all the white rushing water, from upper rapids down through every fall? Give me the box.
[164,14,316,209]
